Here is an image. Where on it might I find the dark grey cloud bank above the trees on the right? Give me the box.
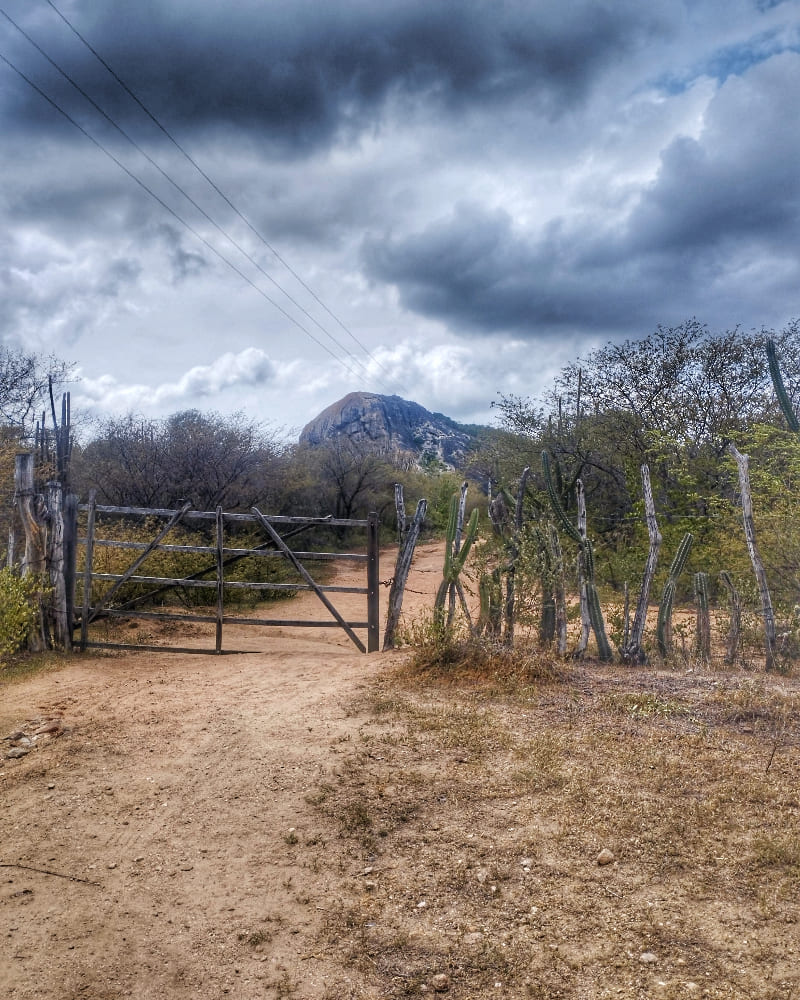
[363,53,800,336]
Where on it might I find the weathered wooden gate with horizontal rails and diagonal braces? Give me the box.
[75,496,380,653]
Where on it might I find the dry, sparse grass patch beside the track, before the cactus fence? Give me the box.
[314,653,800,1000]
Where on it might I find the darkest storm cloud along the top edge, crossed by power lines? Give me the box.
[5,0,664,148]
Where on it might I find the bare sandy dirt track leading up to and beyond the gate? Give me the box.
[0,547,441,1000]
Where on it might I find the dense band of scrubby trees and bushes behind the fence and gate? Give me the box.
[0,321,800,664]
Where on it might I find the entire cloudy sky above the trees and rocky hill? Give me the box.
[0,0,800,436]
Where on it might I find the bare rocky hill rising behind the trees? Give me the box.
[300,392,478,469]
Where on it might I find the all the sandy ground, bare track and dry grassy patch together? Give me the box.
[0,545,800,1000]
